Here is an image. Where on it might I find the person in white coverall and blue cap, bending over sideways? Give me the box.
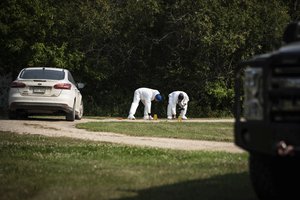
[128,88,163,119]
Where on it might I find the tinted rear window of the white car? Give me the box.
[20,69,65,80]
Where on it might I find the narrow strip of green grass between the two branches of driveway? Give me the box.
[76,122,233,142]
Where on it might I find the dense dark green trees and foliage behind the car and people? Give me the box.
[0,0,300,117]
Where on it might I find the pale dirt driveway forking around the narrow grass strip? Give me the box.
[0,119,243,153]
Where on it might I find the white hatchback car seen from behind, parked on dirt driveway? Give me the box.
[8,67,84,121]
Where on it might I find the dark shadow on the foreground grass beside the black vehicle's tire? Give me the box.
[119,173,257,200]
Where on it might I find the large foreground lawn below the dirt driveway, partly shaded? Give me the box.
[0,132,255,200]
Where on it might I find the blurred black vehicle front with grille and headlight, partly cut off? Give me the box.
[234,22,300,199]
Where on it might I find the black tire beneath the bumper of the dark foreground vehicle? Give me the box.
[249,153,300,200]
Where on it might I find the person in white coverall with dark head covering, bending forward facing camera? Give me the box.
[167,91,189,120]
